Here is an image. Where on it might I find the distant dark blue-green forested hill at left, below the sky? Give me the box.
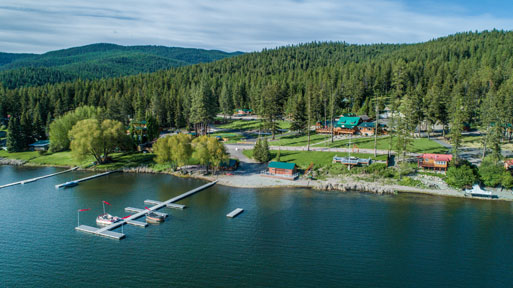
[0,43,242,88]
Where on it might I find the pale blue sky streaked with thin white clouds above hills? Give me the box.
[0,0,513,53]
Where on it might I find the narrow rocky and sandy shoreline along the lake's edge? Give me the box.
[4,158,513,202]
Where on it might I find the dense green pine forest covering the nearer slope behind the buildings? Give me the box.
[0,31,513,153]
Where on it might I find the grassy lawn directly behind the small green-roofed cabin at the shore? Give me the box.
[242,150,387,169]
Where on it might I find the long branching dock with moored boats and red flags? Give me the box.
[75,181,217,240]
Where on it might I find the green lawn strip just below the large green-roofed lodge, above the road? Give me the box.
[317,137,447,153]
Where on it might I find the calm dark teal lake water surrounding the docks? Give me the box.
[0,166,513,288]
